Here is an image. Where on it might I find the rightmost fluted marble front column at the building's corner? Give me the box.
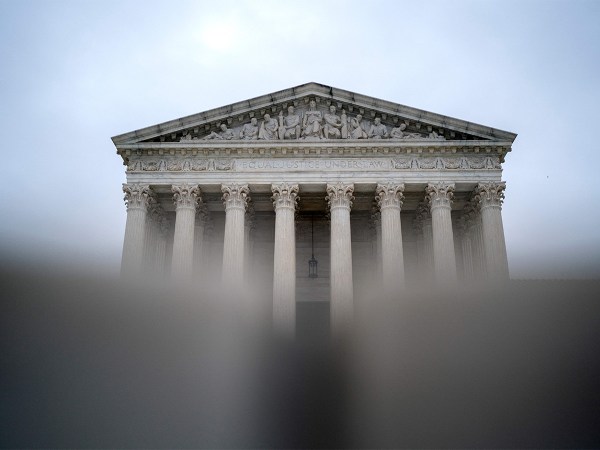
[475,181,509,281]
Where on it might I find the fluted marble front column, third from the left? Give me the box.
[221,183,250,291]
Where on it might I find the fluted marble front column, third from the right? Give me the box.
[375,183,404,296]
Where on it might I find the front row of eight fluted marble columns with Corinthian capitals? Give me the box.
[122,182,508,335]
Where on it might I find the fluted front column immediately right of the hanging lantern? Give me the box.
[326,182,354,337]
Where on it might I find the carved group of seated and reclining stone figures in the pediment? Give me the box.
[181,100,444,141]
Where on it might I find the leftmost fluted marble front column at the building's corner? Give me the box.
[121,184,155,276]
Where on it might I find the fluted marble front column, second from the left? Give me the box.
[171,184,201,280]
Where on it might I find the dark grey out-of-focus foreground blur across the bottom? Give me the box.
[0,268,600,448]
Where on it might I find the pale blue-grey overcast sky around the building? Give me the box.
[0,0,600,278]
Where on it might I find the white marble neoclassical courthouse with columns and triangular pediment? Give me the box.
[112,83,516,330]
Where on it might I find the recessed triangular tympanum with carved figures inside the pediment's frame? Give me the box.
[163,98,474,142]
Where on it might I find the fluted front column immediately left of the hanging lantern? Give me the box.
[271,183,298,337]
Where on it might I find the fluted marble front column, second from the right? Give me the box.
[426,183,457,286]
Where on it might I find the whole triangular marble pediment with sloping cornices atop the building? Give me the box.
[112,83,516,146]
